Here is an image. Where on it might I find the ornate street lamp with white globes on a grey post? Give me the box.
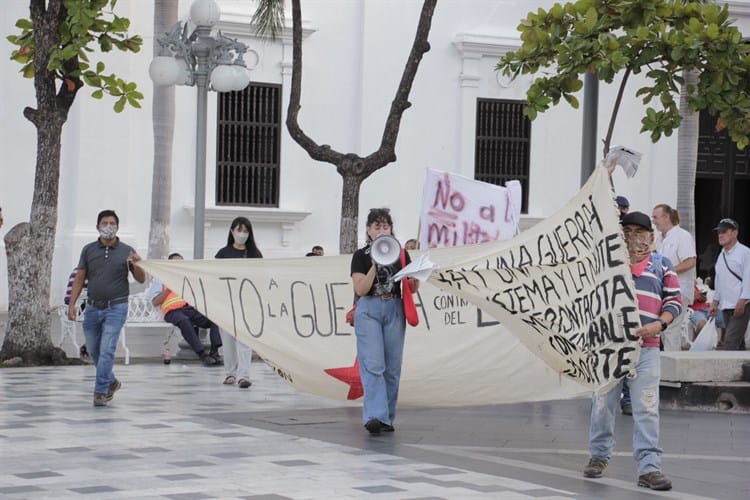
[148,0,250,259]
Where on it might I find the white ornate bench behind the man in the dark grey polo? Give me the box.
[57,290,176,365]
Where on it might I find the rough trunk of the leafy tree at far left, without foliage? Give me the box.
[0,0,81,365]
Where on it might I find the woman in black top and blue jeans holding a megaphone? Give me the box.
[351,208,419,434]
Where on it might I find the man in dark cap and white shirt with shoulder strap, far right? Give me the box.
[709,218,750,351]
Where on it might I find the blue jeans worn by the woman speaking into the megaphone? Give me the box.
[354,297,406,424]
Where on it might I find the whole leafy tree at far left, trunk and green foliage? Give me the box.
[0,0,143,365]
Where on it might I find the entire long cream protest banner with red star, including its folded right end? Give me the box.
[138,168,639,406]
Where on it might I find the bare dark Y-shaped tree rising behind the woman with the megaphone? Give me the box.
[253,0,437,254]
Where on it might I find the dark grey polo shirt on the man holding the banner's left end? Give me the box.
[78,238,133,300]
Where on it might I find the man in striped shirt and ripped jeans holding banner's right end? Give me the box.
[583,212,682,490]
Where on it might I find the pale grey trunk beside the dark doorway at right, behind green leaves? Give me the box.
[676,71,700,238]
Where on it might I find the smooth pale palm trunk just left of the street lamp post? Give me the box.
[148,0,179,259]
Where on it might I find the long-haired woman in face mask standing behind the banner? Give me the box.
[216,217,263,389]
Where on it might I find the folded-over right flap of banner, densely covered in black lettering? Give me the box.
[429,168,641,390]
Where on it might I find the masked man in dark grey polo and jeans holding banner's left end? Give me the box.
[68,210,146,406]
